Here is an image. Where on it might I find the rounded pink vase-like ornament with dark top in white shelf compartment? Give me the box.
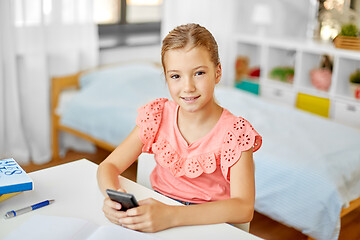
[310,55,333,91]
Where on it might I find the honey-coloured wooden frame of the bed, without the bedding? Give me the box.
[51,72,360,240]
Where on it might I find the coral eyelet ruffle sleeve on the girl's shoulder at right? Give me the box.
[220,117,262,181]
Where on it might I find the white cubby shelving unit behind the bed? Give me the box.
[229,35,360,128]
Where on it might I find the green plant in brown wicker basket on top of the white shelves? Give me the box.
[334,23,360,51]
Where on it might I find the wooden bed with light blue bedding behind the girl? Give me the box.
[52,63,360,239]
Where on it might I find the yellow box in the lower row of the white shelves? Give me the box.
[296,93,330,118]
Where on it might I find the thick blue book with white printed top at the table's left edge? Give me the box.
[0,158,34,195]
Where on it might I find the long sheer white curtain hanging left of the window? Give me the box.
[0,0,98,164]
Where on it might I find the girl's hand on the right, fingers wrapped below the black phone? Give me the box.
[119,198,175,232]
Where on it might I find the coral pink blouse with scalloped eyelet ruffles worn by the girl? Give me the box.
[136,98,262,203]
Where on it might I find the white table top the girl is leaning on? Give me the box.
[0,159,260,240]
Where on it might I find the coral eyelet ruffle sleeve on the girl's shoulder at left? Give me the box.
[136,98,168,153]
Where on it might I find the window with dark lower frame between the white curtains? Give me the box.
[94,0,162,49]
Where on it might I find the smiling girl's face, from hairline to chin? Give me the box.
[164,47,221,112]
